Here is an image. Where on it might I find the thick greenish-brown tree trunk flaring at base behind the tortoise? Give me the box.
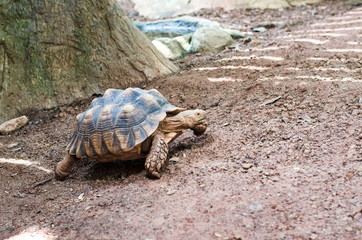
[0,0,178,123]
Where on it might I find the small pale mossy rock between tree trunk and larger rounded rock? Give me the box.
[152,38,187,60]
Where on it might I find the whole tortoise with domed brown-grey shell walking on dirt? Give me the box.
[55,88,207,180]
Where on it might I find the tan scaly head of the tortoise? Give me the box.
[177,109,208,136]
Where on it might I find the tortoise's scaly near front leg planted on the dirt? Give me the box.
[145,135,168,178]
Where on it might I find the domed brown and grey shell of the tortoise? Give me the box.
[67,88,185,158]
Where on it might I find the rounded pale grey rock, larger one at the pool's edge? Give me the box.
[191,27,235,53]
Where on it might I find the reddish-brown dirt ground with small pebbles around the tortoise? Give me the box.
[0,1,362,240]
